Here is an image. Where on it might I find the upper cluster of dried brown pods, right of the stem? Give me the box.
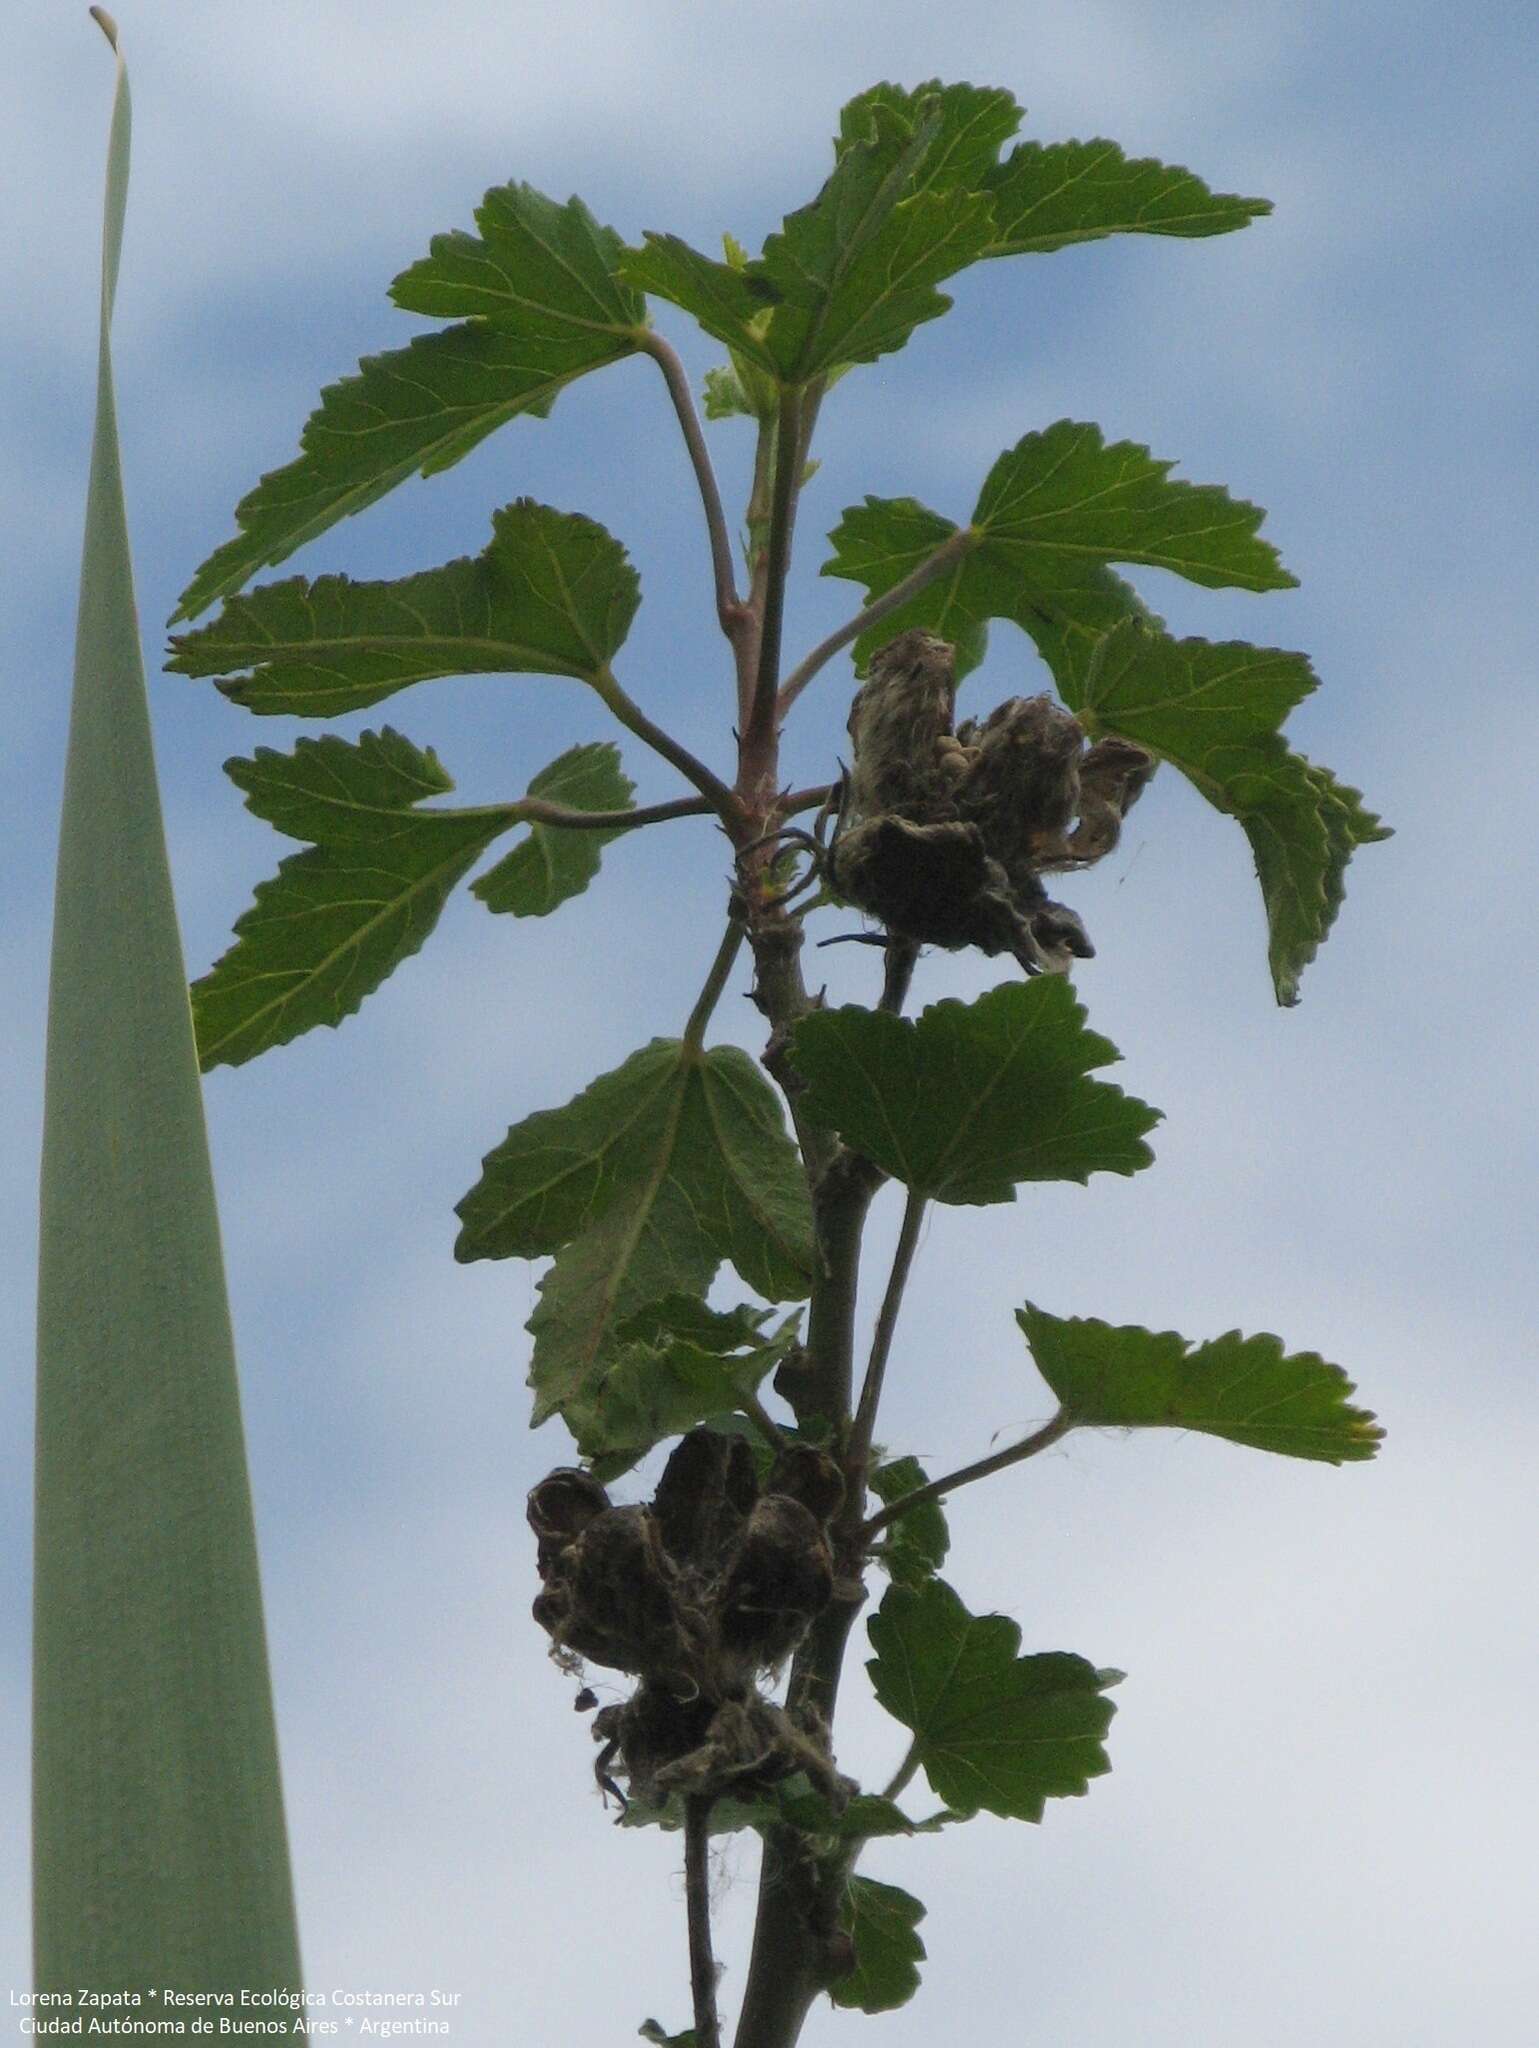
[824,631,1154,975]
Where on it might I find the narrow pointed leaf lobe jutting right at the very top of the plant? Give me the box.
[988,137,1273,256]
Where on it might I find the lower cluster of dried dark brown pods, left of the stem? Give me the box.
[529,1430,848,1806]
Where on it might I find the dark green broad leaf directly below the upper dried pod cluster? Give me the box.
[793,975,1160,1202]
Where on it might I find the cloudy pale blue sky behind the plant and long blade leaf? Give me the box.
[0,0,1539,2048]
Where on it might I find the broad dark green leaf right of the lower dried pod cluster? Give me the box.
[867,1579,1121,1821]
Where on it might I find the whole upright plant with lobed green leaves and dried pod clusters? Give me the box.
[168,82,1383,2048]
